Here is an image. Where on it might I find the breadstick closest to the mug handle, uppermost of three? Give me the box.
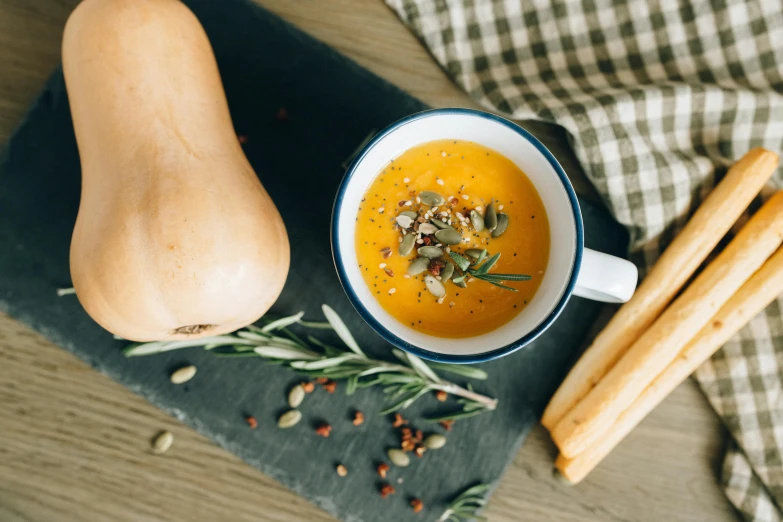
[541,148,778,431]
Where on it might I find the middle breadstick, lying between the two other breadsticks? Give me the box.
[552,191,783,458]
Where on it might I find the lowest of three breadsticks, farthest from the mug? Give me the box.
[555,248,783,484]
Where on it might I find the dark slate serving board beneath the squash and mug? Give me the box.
[0,0,627,522]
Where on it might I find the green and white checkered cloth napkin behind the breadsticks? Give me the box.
[386,0,783,521]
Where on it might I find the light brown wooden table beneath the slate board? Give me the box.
[0,0,735,522]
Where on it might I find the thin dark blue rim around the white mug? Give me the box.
[331,108,584,364]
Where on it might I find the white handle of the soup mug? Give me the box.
[574,248,639,303]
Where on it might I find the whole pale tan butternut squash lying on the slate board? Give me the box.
[62,0,290,341]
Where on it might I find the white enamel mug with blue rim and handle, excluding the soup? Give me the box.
[332,109,638,363]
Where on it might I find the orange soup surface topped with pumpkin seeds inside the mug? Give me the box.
[356,140,549,338]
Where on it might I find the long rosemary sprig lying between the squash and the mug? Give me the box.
[124,305,498,420]
